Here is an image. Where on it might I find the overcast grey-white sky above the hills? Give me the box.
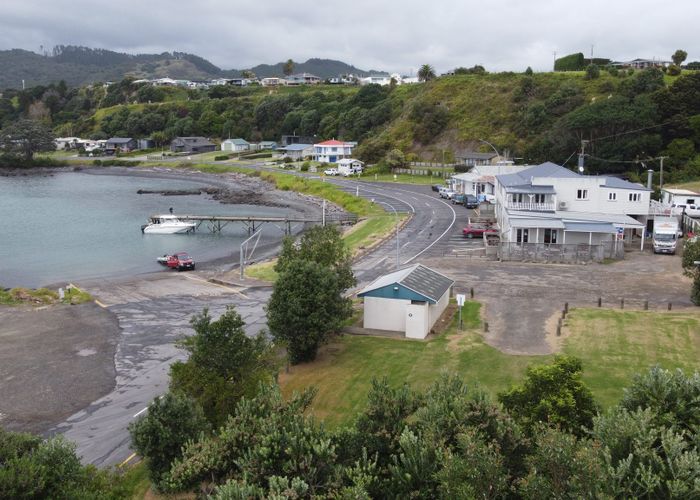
[0,0,700,74]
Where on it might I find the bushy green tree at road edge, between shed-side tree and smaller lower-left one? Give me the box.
[170,306,277,427]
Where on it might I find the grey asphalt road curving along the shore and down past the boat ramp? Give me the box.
[50,174,457,466]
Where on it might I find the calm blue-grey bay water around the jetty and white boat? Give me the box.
[0,172,296,287]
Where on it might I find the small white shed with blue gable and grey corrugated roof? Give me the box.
[357,264,454,339]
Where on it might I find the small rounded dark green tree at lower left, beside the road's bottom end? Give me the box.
[129,392,209,488]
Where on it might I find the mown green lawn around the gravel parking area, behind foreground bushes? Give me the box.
[280,302,700,427]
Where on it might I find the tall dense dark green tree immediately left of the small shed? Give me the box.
[267,259,352,364]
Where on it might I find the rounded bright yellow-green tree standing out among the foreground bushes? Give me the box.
[498,356,598,436]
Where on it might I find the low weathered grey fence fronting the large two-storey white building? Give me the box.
[498,241,625,263]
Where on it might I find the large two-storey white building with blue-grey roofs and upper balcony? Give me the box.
[495,162,650,254]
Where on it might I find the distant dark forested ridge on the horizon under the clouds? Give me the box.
[0,45,383,89]
